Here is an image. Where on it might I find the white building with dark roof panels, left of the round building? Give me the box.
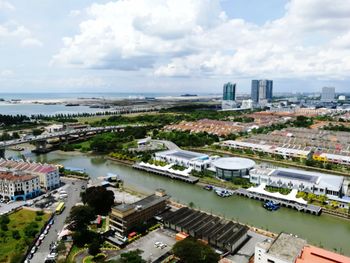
[154,150,211,171]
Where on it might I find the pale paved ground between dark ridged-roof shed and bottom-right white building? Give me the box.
[226,230,268,263]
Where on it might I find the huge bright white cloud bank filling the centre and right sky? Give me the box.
[52,0,350,79]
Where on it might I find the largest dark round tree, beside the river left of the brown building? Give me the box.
[81,186,114,215]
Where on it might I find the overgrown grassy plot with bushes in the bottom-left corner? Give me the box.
[0,209,50,262]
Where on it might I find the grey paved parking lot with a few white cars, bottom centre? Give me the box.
[112,229,176,262]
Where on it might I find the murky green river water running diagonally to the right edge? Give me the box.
[17,152,350,256]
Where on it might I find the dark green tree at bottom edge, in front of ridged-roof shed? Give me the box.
[173,238,220,263]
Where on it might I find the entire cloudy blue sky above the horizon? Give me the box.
[0,0,350,94]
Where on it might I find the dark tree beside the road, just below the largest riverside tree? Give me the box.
[66,206,96,231]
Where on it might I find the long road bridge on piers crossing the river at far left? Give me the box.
[0,125,134,158]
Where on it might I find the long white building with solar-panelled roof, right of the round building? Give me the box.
[249,167,344,197]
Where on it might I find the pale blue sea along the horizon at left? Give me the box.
[0,93,214,116]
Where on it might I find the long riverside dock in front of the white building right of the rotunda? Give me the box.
[234,189,322,215]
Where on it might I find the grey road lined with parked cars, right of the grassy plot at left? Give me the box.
[30,179,87,263]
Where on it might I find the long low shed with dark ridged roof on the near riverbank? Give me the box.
[162,207,249,253]
